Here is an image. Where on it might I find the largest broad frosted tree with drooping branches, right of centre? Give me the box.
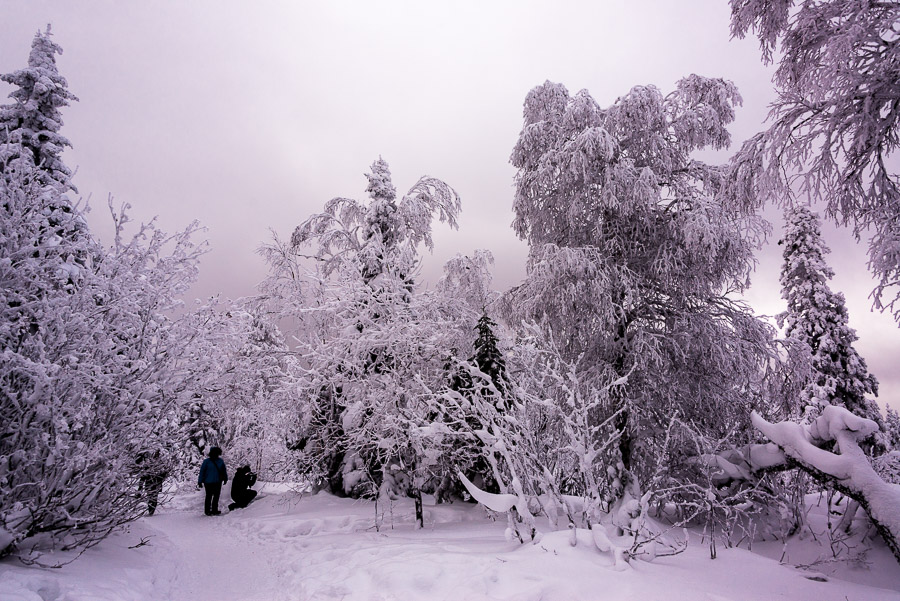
[505,75,774,528]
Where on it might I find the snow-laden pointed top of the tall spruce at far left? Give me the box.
[0,25,77,191]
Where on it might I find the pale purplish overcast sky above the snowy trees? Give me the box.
[0,0,900,407]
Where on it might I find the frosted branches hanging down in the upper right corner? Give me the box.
[730,0,900,321]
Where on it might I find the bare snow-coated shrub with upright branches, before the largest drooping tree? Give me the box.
[448,327,624,541]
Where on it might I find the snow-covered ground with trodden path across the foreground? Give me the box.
[0,484,900,601]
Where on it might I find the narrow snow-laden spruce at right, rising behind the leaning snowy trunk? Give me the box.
[778,206,887,440]
